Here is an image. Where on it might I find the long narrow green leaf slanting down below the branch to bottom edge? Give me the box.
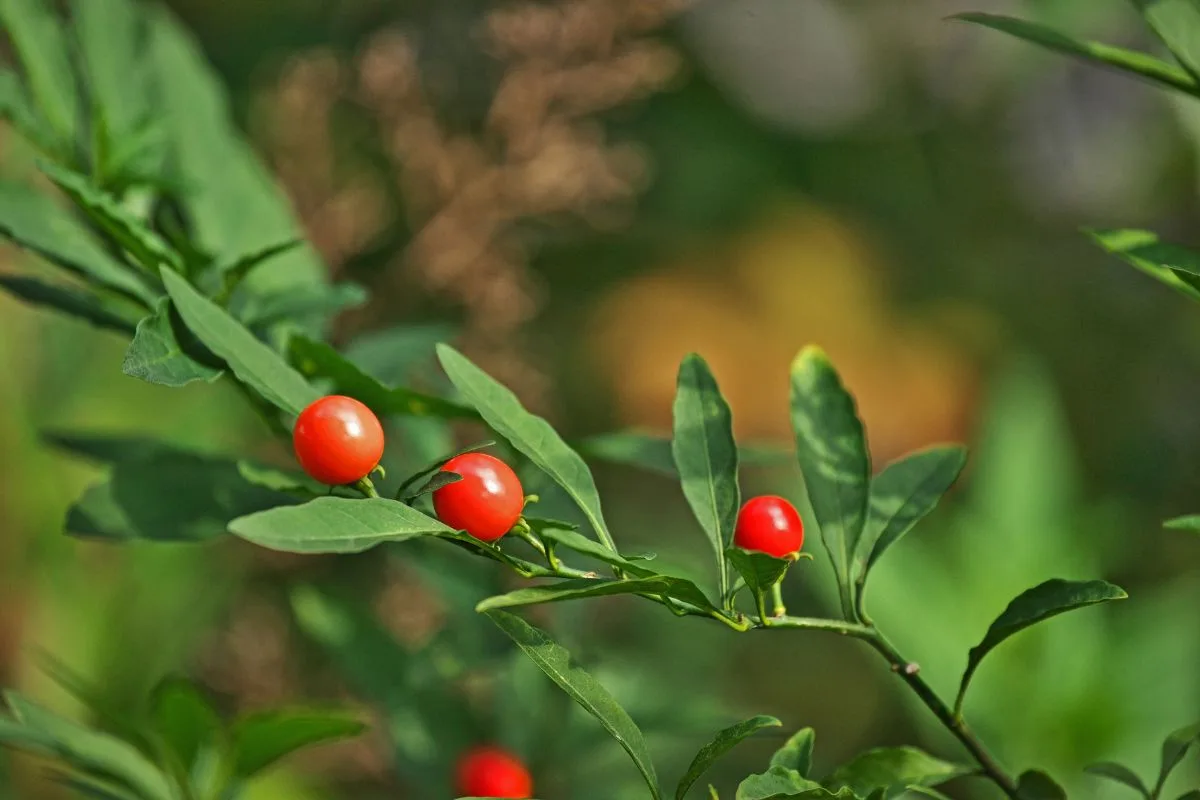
[482,609,662,800]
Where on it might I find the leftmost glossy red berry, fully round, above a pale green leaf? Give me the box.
[292,395,383,486]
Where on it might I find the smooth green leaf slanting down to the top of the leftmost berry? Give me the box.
[162,269,319,415]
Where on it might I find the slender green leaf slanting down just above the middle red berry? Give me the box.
[438,344,617,551]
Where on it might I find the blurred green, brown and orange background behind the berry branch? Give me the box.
[0,0,1200,800]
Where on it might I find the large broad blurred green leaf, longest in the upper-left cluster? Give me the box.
[149,6,325,291]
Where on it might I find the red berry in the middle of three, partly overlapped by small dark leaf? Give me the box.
[433,453,524,542]
